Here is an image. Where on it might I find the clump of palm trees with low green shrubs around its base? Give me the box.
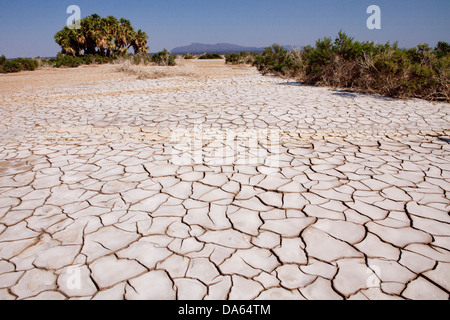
[0,14,156,73]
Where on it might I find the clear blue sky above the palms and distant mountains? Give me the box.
[0,0,450,58]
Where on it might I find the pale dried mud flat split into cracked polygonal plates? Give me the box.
[0,62,450,300]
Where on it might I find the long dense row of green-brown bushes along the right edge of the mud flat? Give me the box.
[254,32,450,101]
